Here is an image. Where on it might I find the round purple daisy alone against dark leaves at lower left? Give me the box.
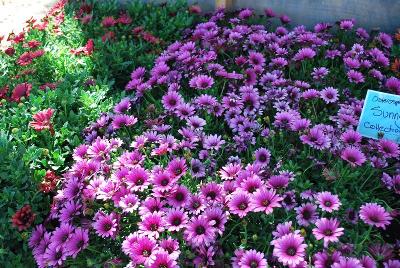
[93,211,119,238]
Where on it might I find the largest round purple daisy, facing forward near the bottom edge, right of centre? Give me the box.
[271,233,307,266]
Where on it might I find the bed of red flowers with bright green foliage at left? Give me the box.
[0,1,200,267]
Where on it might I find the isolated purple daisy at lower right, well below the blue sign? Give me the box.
[360,203,392,229]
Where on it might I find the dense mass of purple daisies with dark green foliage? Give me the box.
[29,6,400,268]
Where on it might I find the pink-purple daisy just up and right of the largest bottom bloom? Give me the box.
[312,218,344,247]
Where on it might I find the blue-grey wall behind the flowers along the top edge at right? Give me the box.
[139,0,400,33]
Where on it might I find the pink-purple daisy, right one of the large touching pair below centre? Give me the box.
[250,188,283,214]
